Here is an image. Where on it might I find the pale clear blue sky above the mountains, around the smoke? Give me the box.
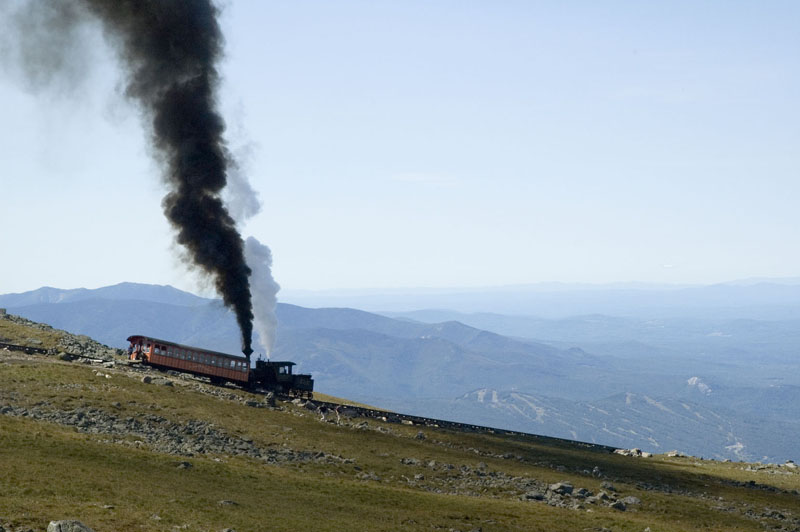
[0,0,800,293]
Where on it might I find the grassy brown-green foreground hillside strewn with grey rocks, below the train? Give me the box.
[0,319,800,532]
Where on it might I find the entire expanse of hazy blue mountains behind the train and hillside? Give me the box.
[0,283,800,460]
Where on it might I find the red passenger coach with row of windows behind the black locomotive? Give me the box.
[128,335,250,385]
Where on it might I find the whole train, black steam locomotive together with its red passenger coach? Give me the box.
[128,335,314,399]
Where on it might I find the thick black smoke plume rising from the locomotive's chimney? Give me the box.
[0,0,253,358]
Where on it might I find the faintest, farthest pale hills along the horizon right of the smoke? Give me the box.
[287,278,800,320]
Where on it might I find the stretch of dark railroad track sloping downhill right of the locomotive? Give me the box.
[287,397,617,453]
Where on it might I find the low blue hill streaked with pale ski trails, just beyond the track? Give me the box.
[382,388,800,461]
